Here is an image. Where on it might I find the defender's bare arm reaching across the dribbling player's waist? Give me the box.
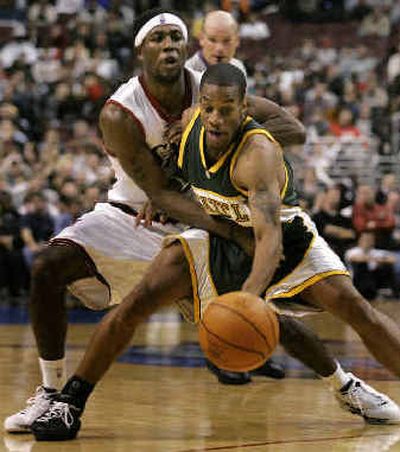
[100,104,252,253]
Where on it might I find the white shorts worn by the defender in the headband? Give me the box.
[51,203,184,310]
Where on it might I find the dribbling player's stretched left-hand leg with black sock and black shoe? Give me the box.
[32,243,192,440]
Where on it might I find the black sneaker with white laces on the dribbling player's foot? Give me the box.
[31,394,82,441]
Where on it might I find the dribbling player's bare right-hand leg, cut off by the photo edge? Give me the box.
[302,276,400,377]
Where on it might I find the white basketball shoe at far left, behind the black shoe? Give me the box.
[4,386,57,433]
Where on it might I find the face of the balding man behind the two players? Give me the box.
[199,24,239,65]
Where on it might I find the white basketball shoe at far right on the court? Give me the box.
[335,373,400,424]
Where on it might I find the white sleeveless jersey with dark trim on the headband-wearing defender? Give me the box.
[107,69,200,209]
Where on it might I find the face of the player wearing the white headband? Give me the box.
[139,25,187,82]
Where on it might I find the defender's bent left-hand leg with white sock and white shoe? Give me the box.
[4,244,92,432]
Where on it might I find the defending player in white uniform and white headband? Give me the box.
[4,10,304,432]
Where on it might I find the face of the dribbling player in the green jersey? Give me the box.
[200,83,245,152]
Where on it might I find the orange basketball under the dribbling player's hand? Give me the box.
[199,292,279,372]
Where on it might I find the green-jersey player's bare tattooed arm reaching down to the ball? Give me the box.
[233,135,285,295]
